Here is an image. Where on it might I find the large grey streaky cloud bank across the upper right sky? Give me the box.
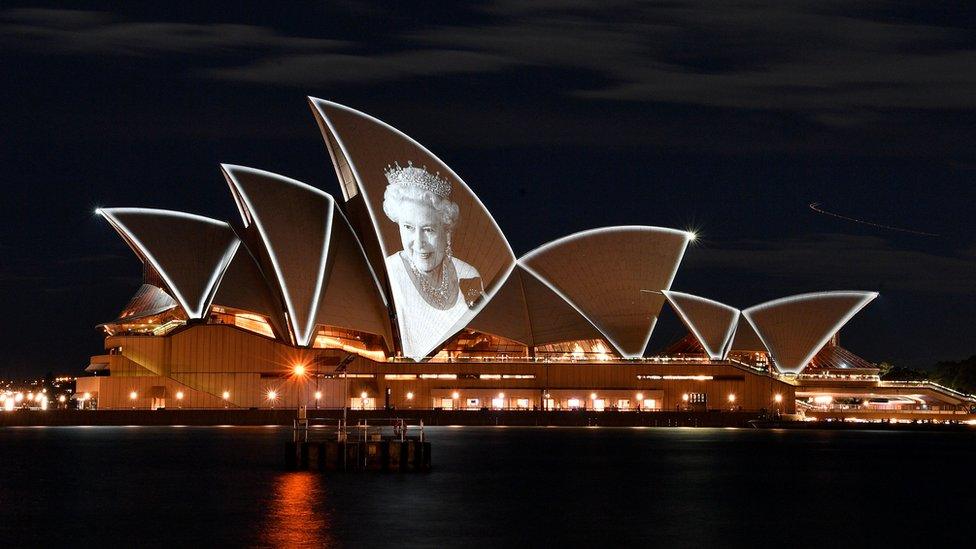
[414,2,976,113]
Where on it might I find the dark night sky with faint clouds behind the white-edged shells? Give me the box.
[0,0,976,377]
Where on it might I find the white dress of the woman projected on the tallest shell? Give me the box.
[386,252,479,360]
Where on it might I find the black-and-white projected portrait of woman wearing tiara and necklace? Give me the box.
[383,163,484,358]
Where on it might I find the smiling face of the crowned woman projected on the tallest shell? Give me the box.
[399,200,447,273]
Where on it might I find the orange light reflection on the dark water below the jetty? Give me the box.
[260,472,336,547]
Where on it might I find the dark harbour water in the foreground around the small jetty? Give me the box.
[0,427,976,547]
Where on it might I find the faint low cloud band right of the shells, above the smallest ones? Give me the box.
[682,234,976,298]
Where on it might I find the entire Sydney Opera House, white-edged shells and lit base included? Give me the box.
[77,99,970,413]
